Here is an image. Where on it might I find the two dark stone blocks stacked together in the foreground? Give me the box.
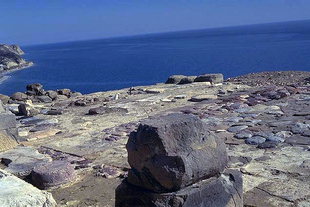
[115,114,243,207]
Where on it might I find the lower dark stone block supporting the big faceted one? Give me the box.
[115,170,243,207]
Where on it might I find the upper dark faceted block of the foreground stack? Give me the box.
[126,114,227,192]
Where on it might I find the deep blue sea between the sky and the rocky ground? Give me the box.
[0,20,310,95]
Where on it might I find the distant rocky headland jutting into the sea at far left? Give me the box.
[0,44,33,74]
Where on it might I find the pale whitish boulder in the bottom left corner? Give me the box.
[0,169,56,207]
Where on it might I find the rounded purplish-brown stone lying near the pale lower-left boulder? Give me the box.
[31,160,75,189]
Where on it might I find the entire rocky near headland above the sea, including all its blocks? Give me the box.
[0,71,310,207]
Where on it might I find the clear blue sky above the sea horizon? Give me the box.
[0,0,310,45]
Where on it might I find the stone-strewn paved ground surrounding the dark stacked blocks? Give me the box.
[0,72,310,207]
